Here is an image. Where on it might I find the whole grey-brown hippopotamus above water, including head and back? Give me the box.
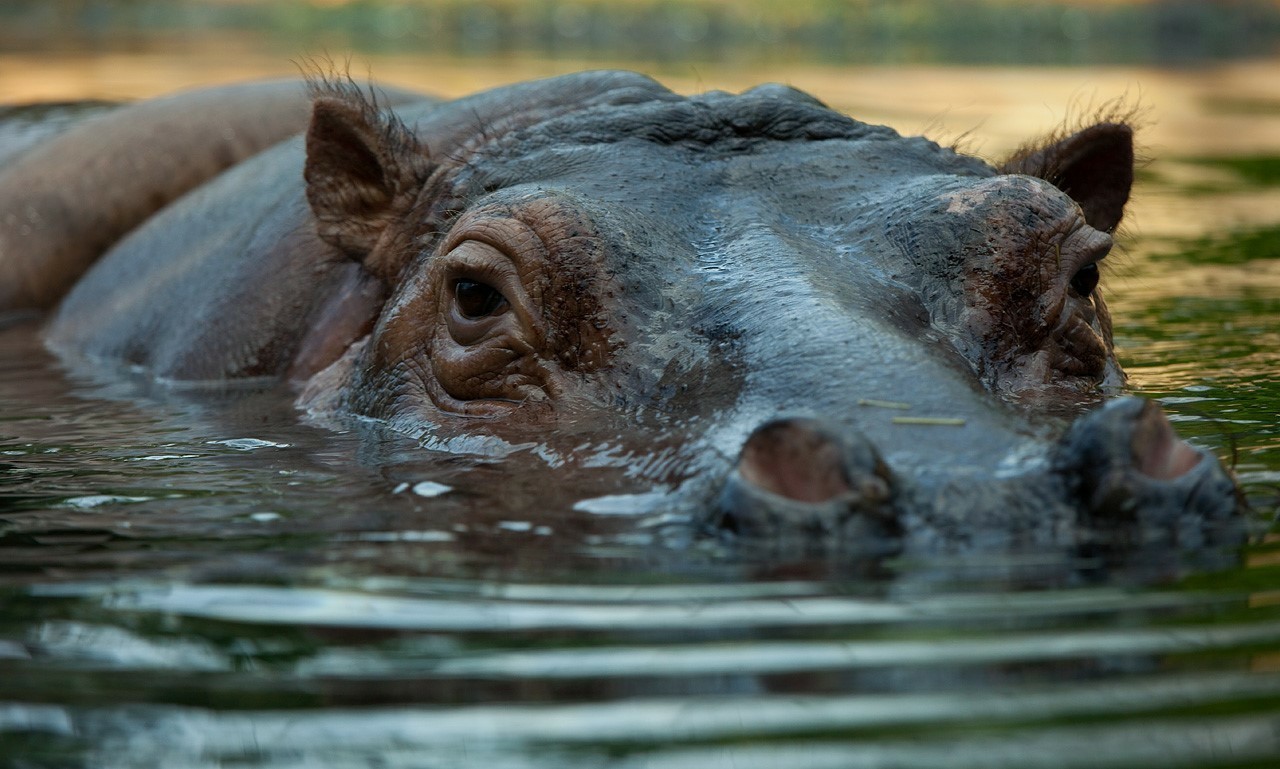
[0,72,1242,555]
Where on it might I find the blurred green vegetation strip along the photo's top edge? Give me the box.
[0,0,1280,65]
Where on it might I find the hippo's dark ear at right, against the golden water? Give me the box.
[1000,123,1133,233]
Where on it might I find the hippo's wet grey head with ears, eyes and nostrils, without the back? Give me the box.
[293,73,1238,553]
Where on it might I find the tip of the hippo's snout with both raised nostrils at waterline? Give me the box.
[716,397,1242,555]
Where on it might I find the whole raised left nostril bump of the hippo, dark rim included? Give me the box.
[714,418,900,553]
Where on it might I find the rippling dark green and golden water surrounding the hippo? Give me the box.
[0,25,1280,769]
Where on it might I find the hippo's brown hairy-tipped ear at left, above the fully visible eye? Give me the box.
[303,90,431,279]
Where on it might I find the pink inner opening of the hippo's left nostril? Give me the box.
[737,420,852,503]
